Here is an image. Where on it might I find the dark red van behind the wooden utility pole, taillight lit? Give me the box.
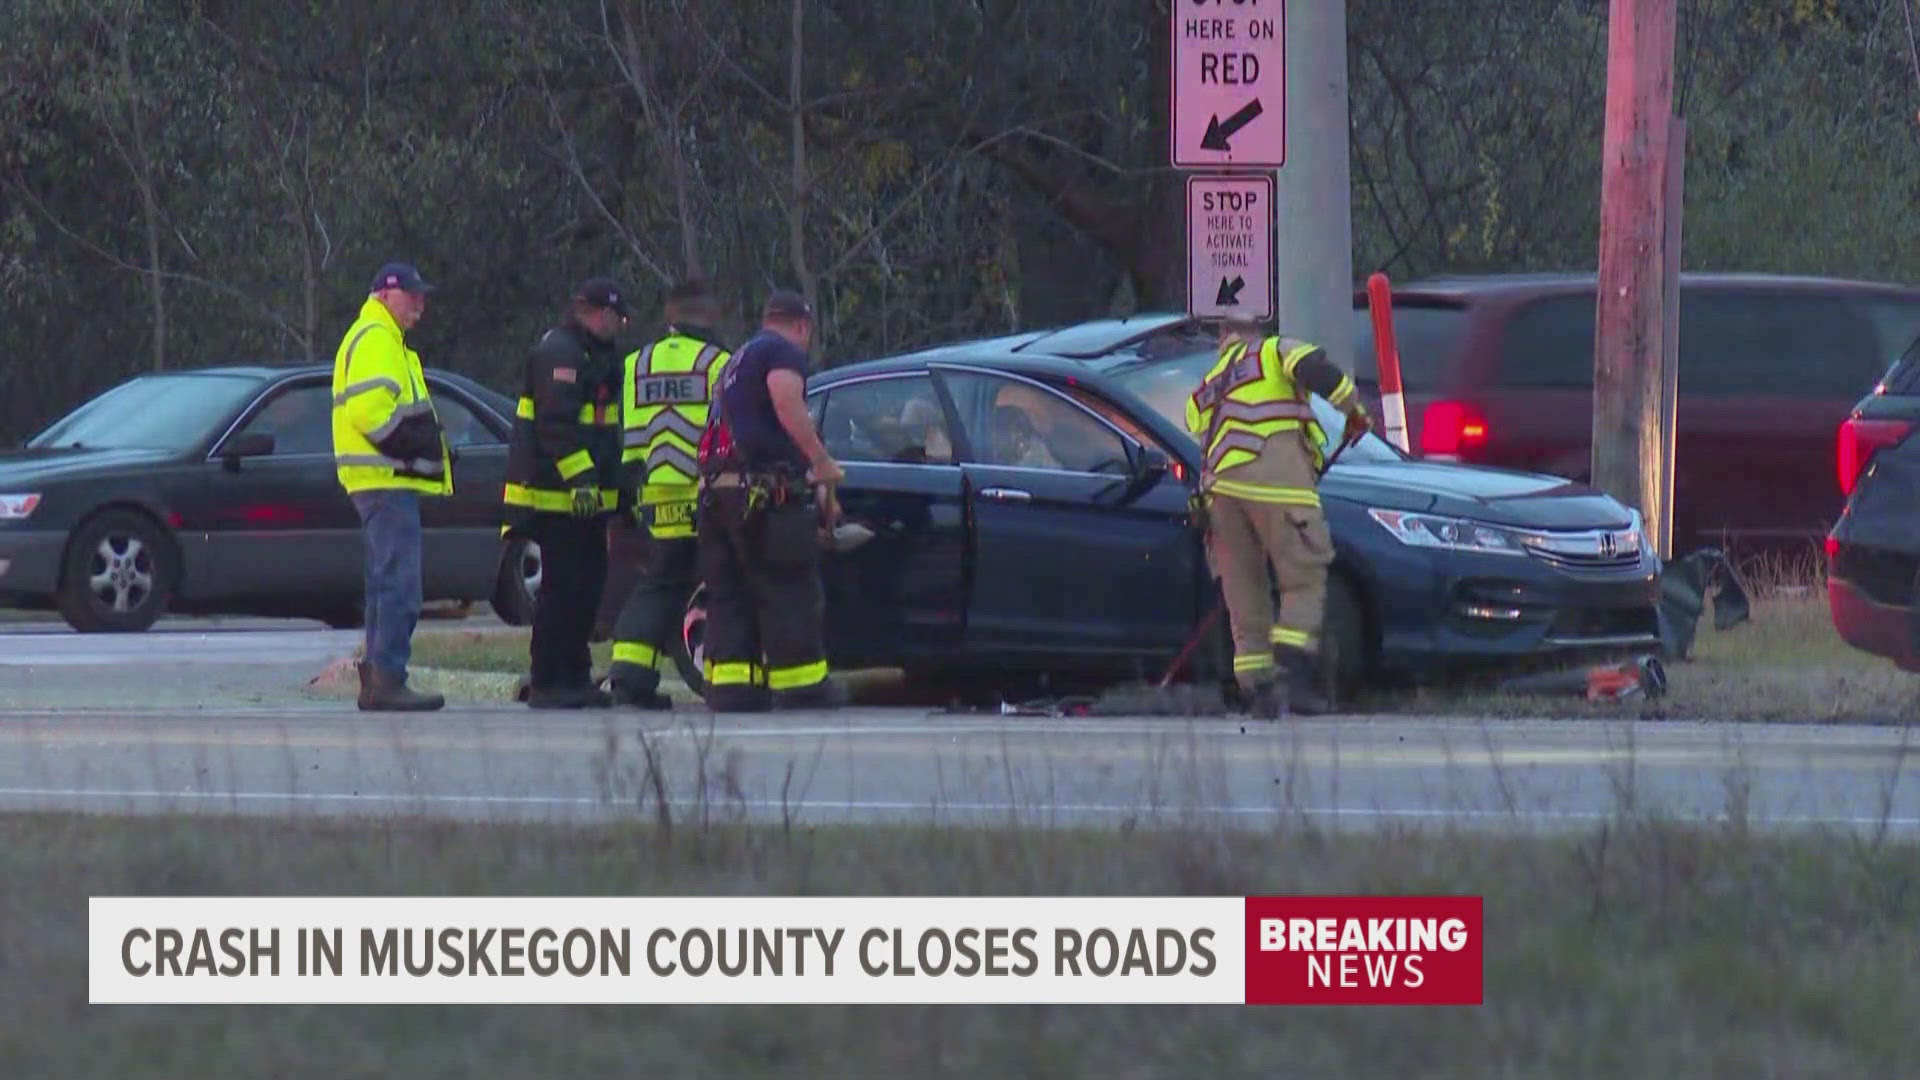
[1354,273,1920,553]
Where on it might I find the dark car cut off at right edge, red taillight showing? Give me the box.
[1826,330,1920,671]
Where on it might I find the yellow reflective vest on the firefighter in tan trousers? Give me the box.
[1187,338,1354,505]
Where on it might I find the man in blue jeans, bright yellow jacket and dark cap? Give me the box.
[332,263,453,711]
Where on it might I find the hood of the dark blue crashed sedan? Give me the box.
[1321,461,1632,528]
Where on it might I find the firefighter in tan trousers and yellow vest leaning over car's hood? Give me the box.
[1187,321,1371,719]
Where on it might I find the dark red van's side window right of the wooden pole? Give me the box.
[1680,290,1887,398]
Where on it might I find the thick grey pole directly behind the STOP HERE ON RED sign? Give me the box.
[1273,0,1357,371]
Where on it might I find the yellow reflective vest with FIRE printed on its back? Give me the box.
[620,332,732,540]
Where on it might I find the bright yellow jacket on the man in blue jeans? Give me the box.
[332,296,453,496]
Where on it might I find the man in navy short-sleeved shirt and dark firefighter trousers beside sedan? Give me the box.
[697,290,843,711]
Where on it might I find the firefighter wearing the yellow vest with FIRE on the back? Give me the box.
[609,281,730,709]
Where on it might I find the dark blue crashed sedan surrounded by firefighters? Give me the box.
[660,315,1659,690]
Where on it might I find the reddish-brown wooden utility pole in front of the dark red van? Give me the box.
[1589,0,1674,536]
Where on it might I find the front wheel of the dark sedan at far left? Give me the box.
[58,509,179,634]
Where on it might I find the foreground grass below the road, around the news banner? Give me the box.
[0,815,1920,1080]
